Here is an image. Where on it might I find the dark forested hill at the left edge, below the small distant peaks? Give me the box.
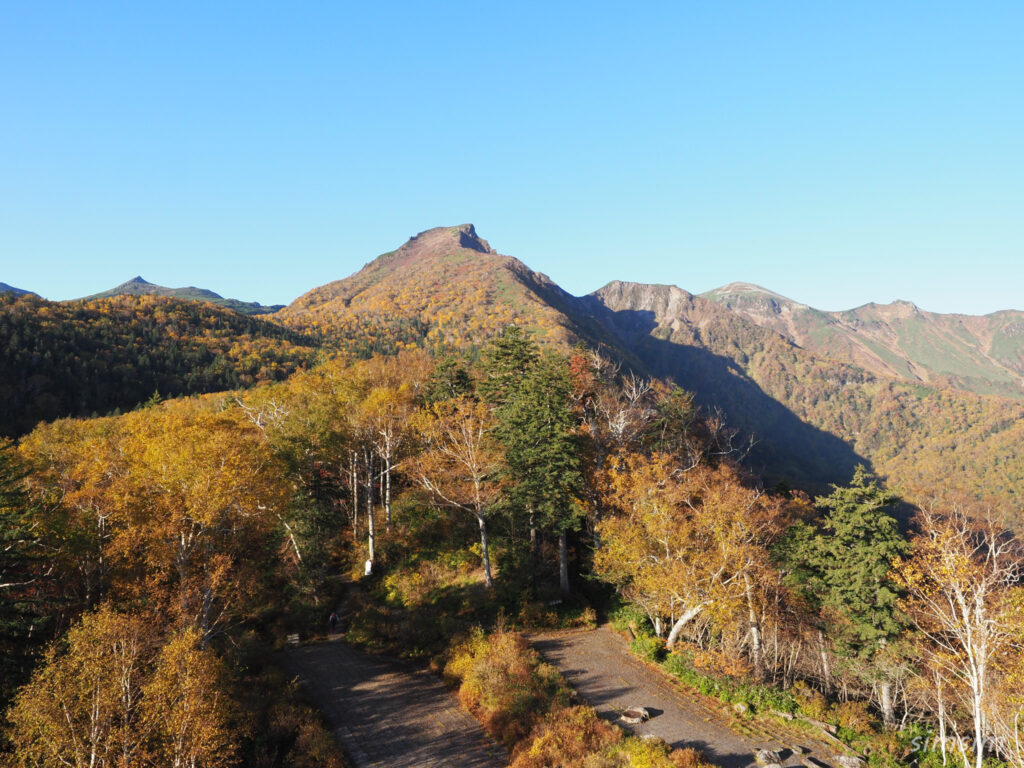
[0,294,318,435]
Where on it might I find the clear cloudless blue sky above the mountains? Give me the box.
[0,0,1024,312]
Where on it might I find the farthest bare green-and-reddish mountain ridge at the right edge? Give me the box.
[702,283,1024,398]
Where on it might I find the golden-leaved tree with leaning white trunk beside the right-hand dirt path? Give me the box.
[594,454,787,666]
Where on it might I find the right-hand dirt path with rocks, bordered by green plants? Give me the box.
[530,626,833,768]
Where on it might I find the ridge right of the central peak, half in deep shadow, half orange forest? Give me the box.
[583,283,1024,501]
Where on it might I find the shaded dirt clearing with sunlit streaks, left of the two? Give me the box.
[283,636,508,768]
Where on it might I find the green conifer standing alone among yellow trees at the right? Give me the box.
[775,466,908,725]
